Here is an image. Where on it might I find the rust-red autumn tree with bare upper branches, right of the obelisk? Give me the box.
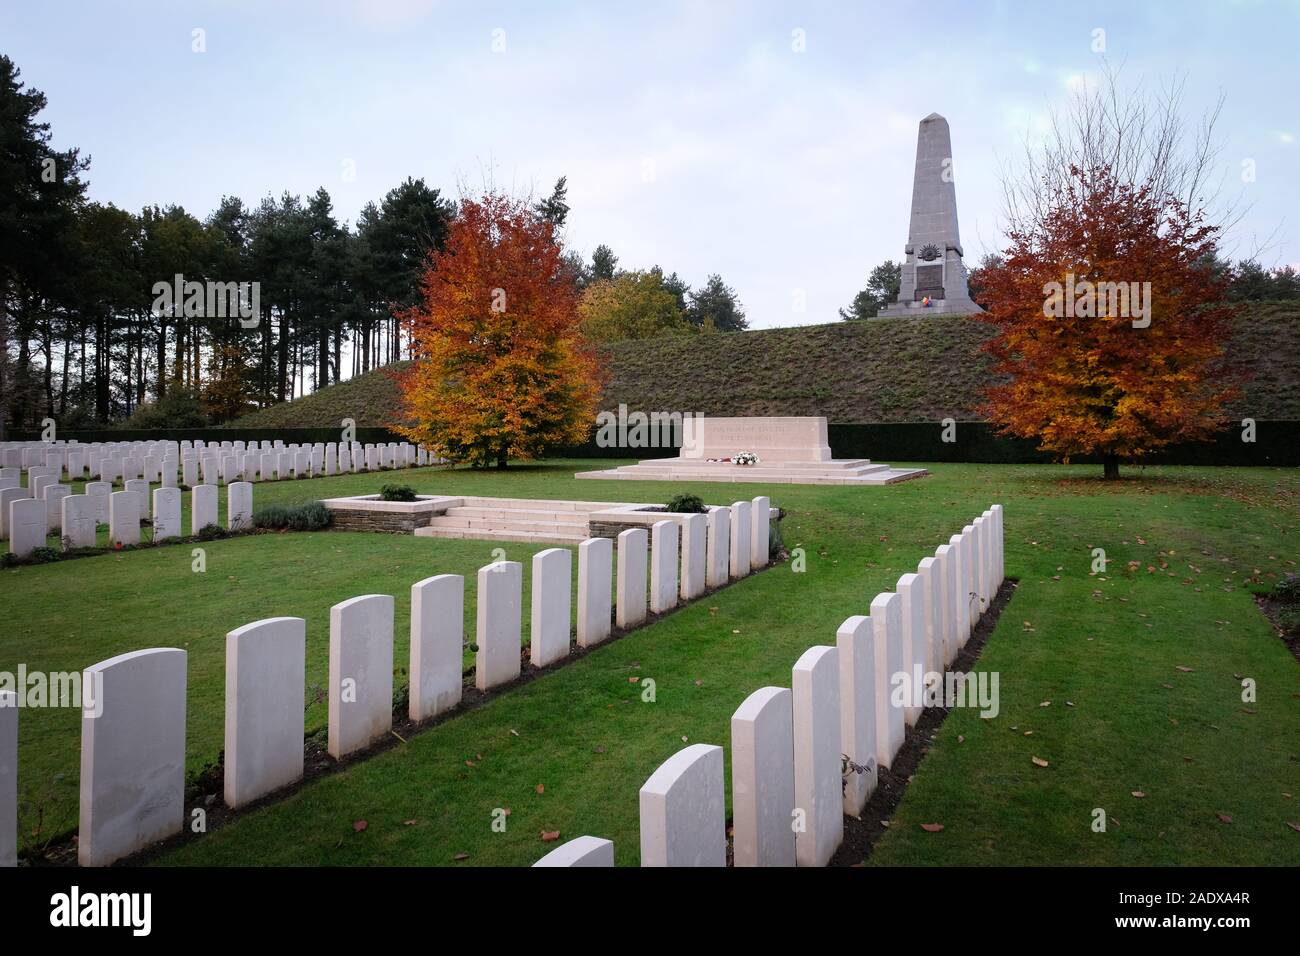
[976,76,1238,479]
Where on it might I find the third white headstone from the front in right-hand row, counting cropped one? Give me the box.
[732,687,794,866]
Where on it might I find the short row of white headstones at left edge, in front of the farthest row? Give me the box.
[0,479,252,558]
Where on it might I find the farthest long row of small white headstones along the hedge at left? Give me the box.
[0,440,441,497]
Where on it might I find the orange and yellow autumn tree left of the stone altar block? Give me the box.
[394,193,601,468]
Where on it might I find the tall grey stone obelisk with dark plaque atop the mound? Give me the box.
[878,113,983,316]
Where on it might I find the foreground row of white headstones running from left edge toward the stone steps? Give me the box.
[0,502,772,866]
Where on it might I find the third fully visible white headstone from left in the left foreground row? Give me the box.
[327,594,393,760]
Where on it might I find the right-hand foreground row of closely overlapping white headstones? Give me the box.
[534,505,1005,866]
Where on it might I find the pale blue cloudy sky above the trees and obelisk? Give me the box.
[0,0,1300,328]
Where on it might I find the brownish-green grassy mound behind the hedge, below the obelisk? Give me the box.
[226,302,1300,428]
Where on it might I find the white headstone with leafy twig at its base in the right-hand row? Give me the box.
[835,614,876,817]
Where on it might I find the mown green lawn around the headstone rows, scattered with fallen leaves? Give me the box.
[0,462,1300,865]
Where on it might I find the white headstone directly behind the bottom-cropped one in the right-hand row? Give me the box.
[641,744,727,866]
